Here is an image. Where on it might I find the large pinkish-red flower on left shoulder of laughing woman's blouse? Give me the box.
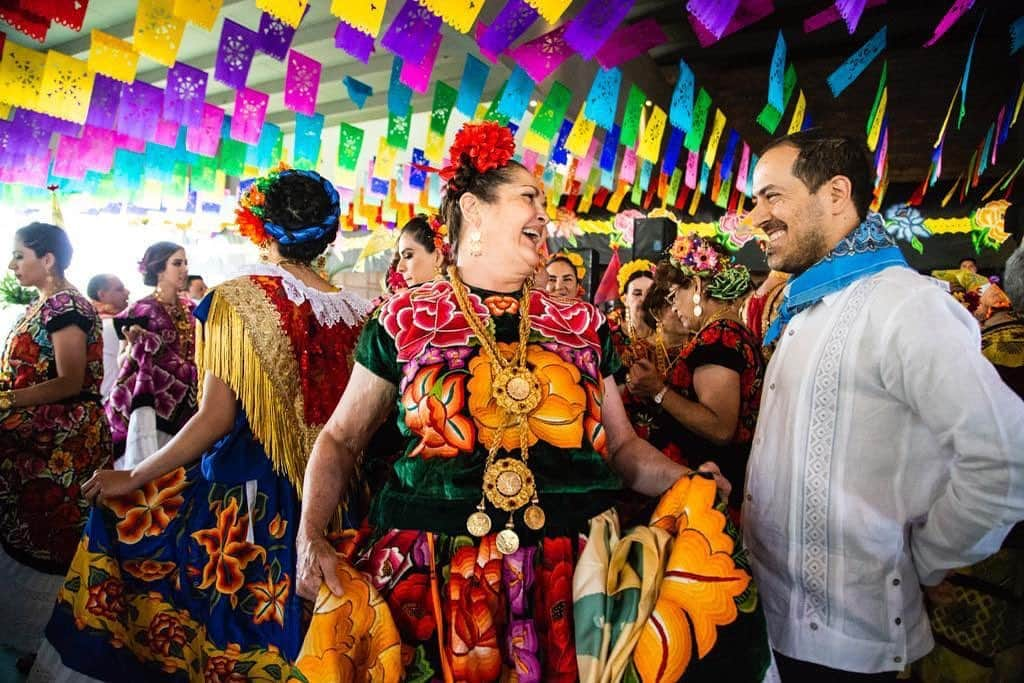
[380,281,489,361]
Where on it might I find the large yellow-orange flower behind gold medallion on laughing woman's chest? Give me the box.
[466,343,587,451]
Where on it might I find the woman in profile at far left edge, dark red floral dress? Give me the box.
[0,223,111,667]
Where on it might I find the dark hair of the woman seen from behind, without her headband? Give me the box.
[263,171,338,263]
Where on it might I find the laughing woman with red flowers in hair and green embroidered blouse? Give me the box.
[298,122,767,683]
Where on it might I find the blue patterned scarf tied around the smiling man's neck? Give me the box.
[764,213,909,346]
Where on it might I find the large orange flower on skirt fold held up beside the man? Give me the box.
[633,477,751,682]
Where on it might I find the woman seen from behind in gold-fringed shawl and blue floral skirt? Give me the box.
[34,170,385,681]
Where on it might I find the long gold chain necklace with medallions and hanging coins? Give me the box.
[449,266,546,555]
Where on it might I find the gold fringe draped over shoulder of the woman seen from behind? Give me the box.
[196,278,323,496]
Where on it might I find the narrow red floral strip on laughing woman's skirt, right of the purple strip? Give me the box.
[535,537,577,683]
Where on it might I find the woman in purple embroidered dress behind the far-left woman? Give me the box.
[106,242,197,469]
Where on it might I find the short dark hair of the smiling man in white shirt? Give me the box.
[761,128,874,220]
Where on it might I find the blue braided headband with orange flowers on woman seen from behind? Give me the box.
[234,164,341,247]
